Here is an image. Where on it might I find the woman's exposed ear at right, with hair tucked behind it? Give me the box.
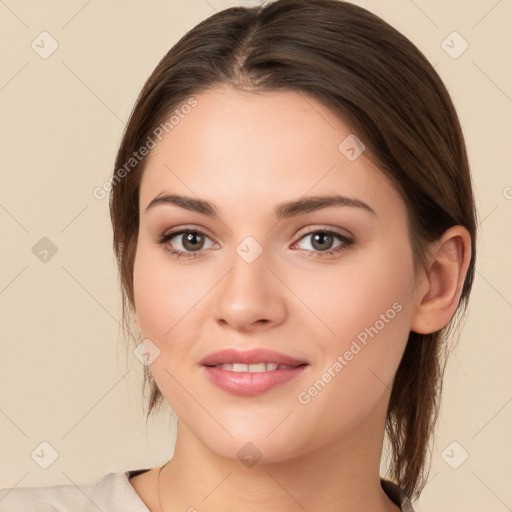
[411,226,471,334]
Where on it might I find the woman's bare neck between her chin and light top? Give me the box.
[156,394,399,512]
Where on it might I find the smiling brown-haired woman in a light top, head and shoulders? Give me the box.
[0,0,476,512]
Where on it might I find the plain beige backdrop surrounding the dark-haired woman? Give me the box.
[0,0,512,512]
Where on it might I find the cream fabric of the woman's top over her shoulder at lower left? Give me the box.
[0,470,149,512]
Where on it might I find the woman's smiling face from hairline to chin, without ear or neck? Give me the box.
[134,88,420,462]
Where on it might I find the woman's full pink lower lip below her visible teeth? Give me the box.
[203,364,308,396]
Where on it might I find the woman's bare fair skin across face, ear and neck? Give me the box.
[131,87,470,512]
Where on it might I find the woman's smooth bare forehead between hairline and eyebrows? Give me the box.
[140,87,404,222]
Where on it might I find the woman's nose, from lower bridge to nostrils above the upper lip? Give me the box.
[214,244,287,332]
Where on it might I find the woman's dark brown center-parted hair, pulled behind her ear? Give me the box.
[110,0,476,499]
